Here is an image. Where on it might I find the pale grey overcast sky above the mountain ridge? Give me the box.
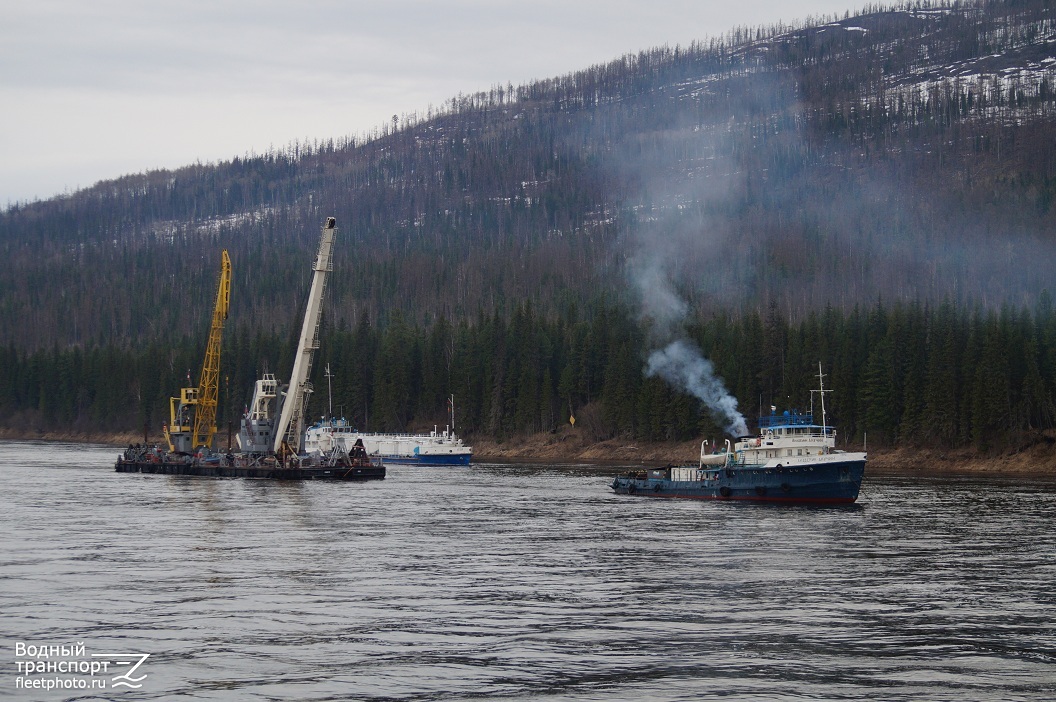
[0,0,866,207]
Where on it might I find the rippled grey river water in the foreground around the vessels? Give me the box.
[0,442,1056,701]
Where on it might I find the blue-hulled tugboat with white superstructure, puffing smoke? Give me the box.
[611,364,866,505]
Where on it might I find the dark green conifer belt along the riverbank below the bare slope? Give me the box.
[0,293,1056,452]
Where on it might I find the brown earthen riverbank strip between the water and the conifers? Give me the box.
[0,428,1056,478]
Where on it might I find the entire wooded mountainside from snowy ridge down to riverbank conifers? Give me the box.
[0,0,1056,451]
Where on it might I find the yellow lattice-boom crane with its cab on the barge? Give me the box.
[165,249,231,453]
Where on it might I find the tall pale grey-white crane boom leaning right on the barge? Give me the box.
[274,217,337,455]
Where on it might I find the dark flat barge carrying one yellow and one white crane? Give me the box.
[114,217,385,480]
